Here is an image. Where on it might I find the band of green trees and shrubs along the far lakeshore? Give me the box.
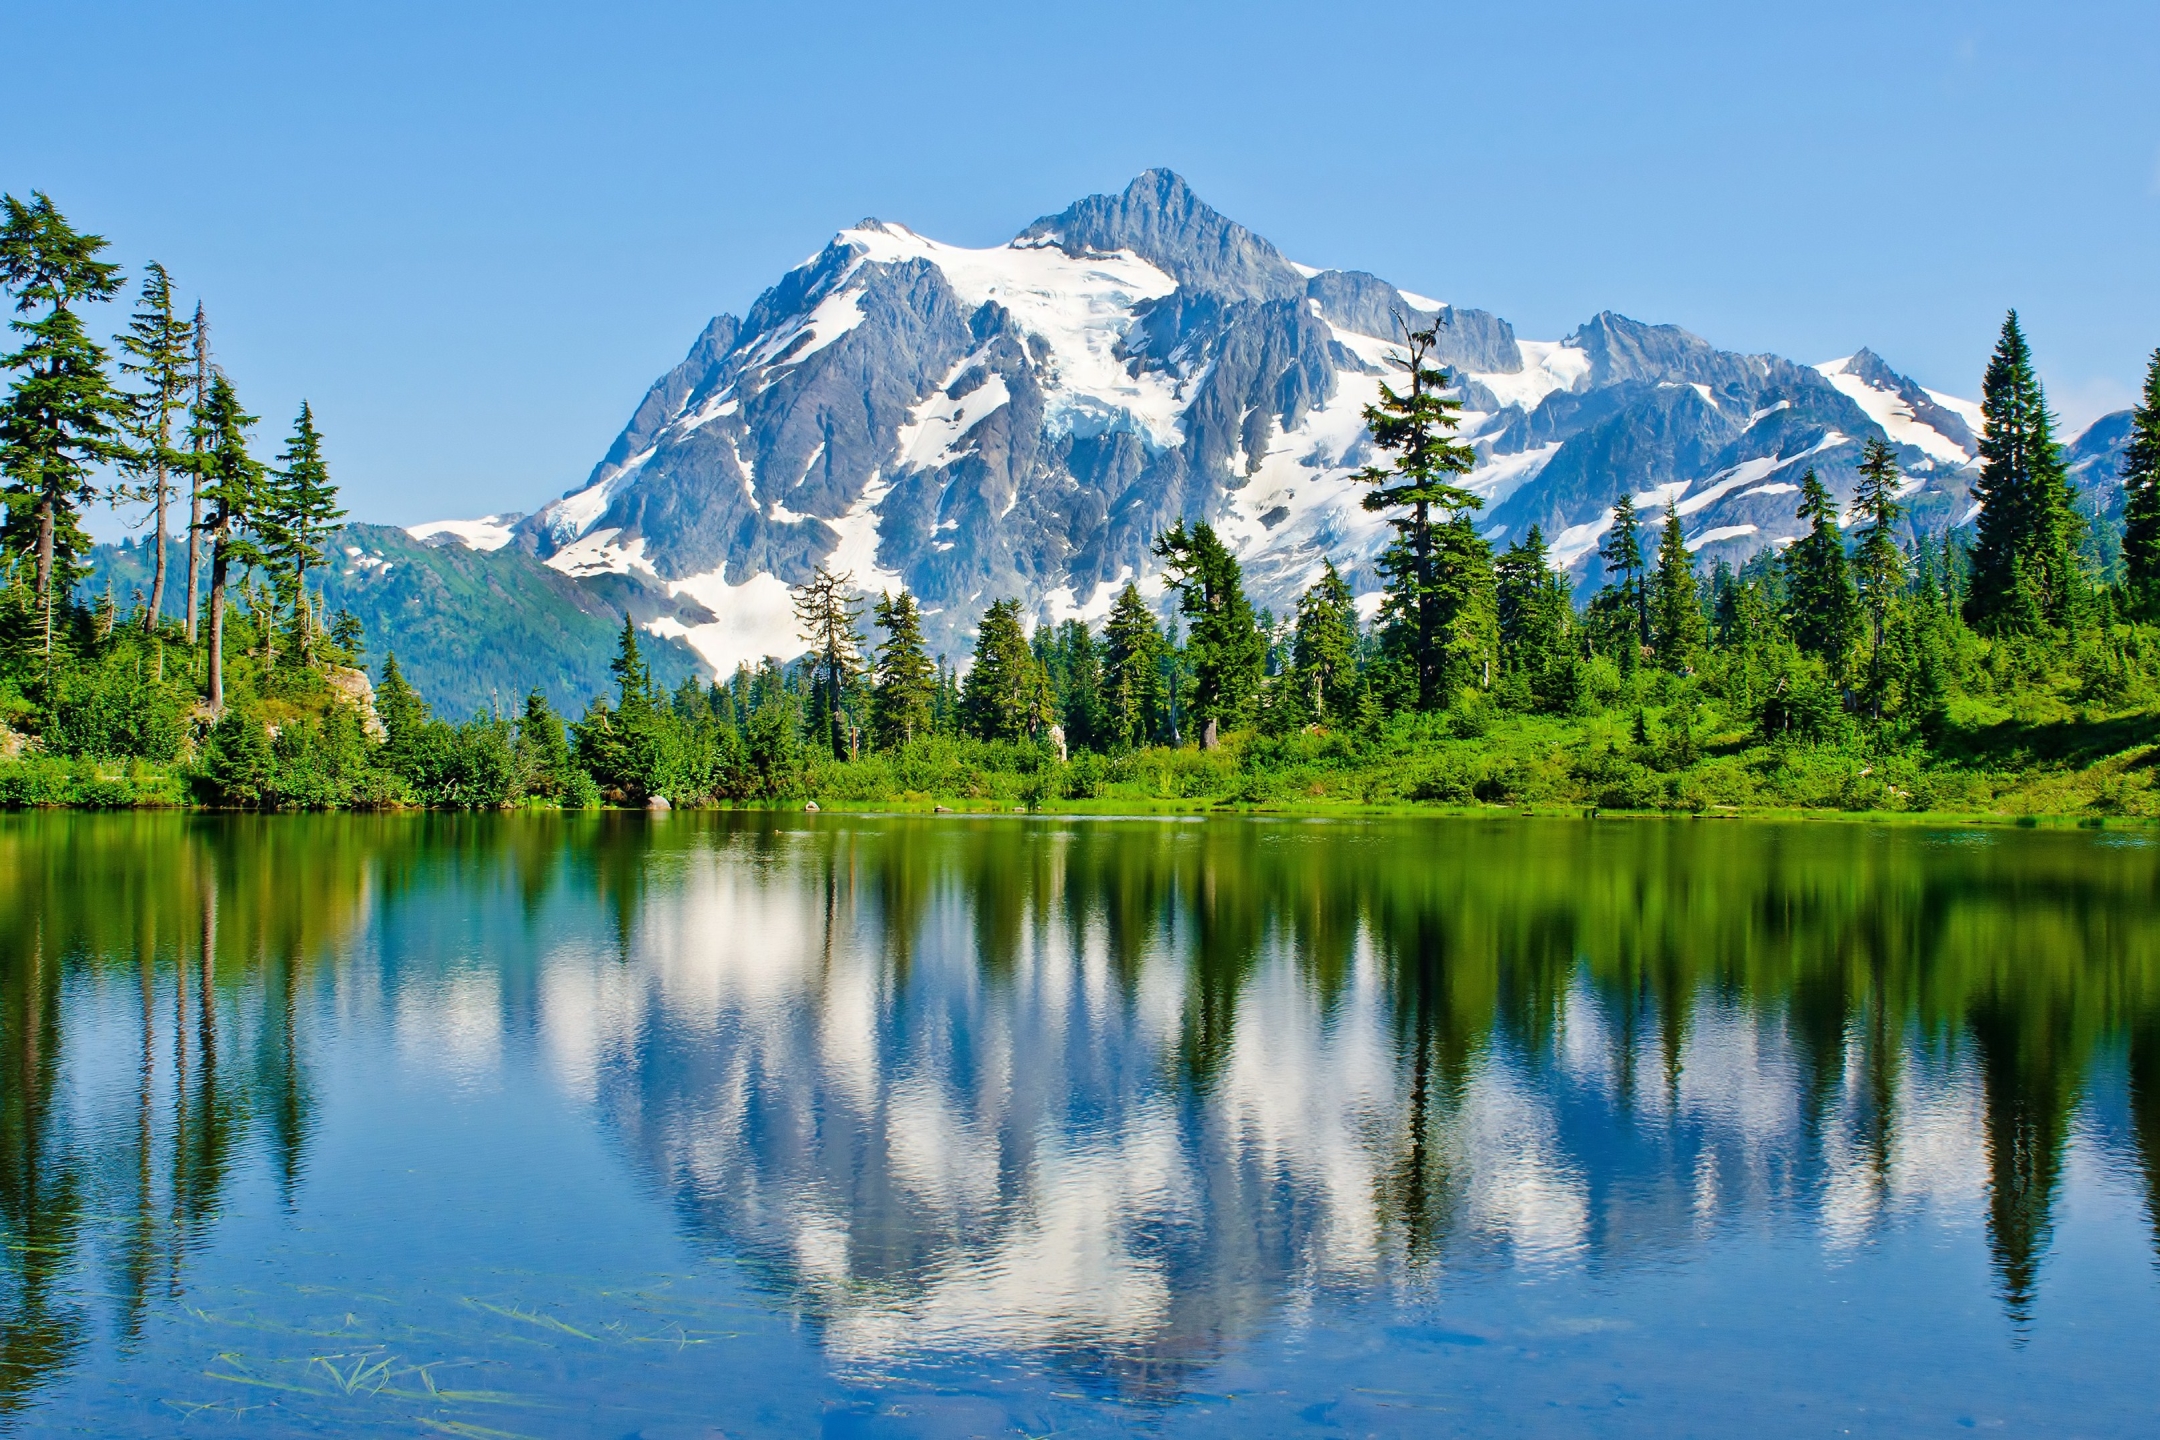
[0,194,2160,825]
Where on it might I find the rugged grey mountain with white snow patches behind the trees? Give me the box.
[413,171,2108,671]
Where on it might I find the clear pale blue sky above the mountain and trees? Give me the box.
[0,0,2160,533]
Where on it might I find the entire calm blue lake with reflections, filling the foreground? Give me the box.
[0,814,2160,1438]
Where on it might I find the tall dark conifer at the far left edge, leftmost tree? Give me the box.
[0,192,127,665]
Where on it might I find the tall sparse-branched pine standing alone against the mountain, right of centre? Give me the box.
[1352,320,1490,710]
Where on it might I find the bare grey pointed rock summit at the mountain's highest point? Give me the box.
[1013,168,1305,300]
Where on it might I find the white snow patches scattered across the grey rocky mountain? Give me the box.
[410,222,1979,674]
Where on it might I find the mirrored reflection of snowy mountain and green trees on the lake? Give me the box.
[0,814,2160,1429]
